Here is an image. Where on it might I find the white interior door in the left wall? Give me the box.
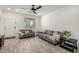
[4,17,16,37]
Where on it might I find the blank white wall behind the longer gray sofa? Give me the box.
[41,6,79,46]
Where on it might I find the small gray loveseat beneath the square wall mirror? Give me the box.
[18,29,35,39]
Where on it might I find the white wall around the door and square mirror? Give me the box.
[0,11,41,35]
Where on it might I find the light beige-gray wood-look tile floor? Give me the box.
[0,37,78,53]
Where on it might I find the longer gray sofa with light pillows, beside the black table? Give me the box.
[37,30,62,45]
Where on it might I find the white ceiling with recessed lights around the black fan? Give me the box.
[0,5,67,16]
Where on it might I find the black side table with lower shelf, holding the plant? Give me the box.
[60,38,77,52]
